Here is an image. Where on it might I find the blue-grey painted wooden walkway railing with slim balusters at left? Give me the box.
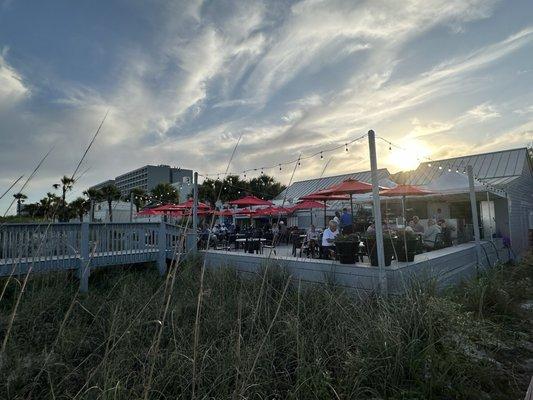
[0,222,186,291]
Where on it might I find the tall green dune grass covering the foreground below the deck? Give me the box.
[0,259,533,400]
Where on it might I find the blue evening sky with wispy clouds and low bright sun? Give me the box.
[0,0,533,211]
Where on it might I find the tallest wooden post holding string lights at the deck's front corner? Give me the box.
[368,130,387,294]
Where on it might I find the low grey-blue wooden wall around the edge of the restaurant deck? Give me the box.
[203,242,509,293]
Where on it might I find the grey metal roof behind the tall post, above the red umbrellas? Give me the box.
[276,168,390,200]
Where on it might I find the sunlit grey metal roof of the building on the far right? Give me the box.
[400,147,527,187]
